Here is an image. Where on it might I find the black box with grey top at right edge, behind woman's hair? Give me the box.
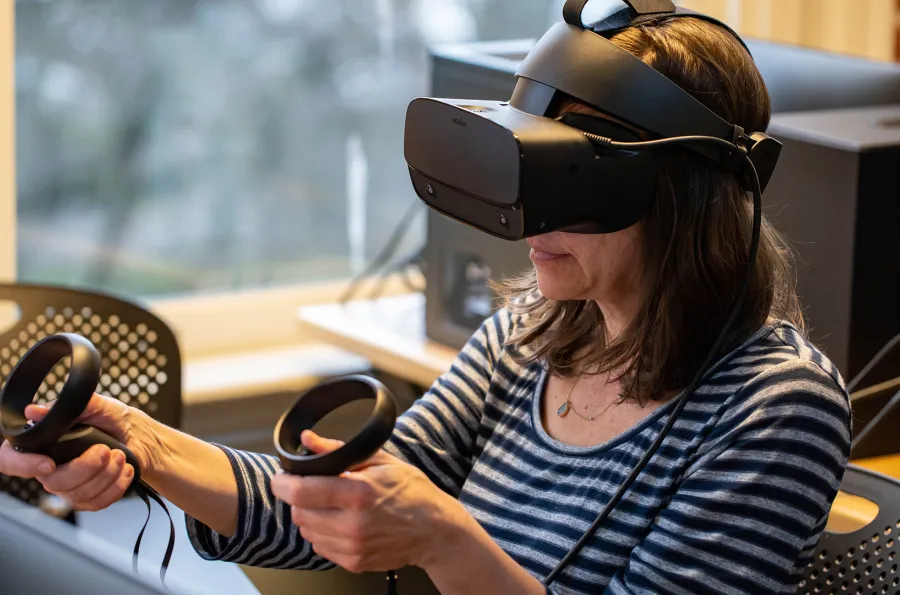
[766,106,900,386]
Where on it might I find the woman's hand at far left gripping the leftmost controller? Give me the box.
[0,394,154,511]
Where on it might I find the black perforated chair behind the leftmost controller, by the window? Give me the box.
[0,284,182,505]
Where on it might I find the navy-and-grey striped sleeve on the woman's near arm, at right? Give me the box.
[606,359,850,595]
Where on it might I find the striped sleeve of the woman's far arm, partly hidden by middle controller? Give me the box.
[185,310,509,570]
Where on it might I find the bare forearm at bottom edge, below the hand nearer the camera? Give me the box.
[423,505,546,595]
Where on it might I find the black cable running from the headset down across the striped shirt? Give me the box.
[544,133,762,585]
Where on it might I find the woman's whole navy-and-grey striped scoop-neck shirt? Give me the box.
[187,310,850,595]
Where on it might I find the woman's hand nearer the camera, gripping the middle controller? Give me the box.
[272,431,468,572]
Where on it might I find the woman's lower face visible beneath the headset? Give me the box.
[527,223,643,313]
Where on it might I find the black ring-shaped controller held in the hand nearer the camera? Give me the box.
[274,375,397,476]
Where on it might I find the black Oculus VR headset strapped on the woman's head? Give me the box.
[404,0,781,240]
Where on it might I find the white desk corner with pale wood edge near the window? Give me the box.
[298,293,458,387]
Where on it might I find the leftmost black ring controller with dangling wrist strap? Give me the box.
[0,333,140,492]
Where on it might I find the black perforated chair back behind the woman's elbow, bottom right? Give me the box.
[797,465,900,595]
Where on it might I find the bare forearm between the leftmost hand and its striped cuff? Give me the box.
[139,418,238,537]
